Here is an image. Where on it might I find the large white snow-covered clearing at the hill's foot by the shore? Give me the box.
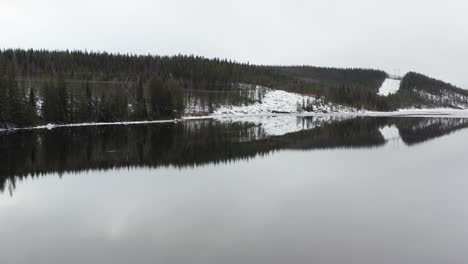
[213,89,357,116]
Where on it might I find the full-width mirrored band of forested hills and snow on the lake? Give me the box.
[0,116,468,192]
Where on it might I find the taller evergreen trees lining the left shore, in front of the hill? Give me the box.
[0,57,184,128]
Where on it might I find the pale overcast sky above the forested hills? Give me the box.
[0,0,468,89]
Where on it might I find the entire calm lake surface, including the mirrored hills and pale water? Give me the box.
[0,117,468,264]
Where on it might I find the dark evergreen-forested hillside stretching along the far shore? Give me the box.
[0,49,468,128]
